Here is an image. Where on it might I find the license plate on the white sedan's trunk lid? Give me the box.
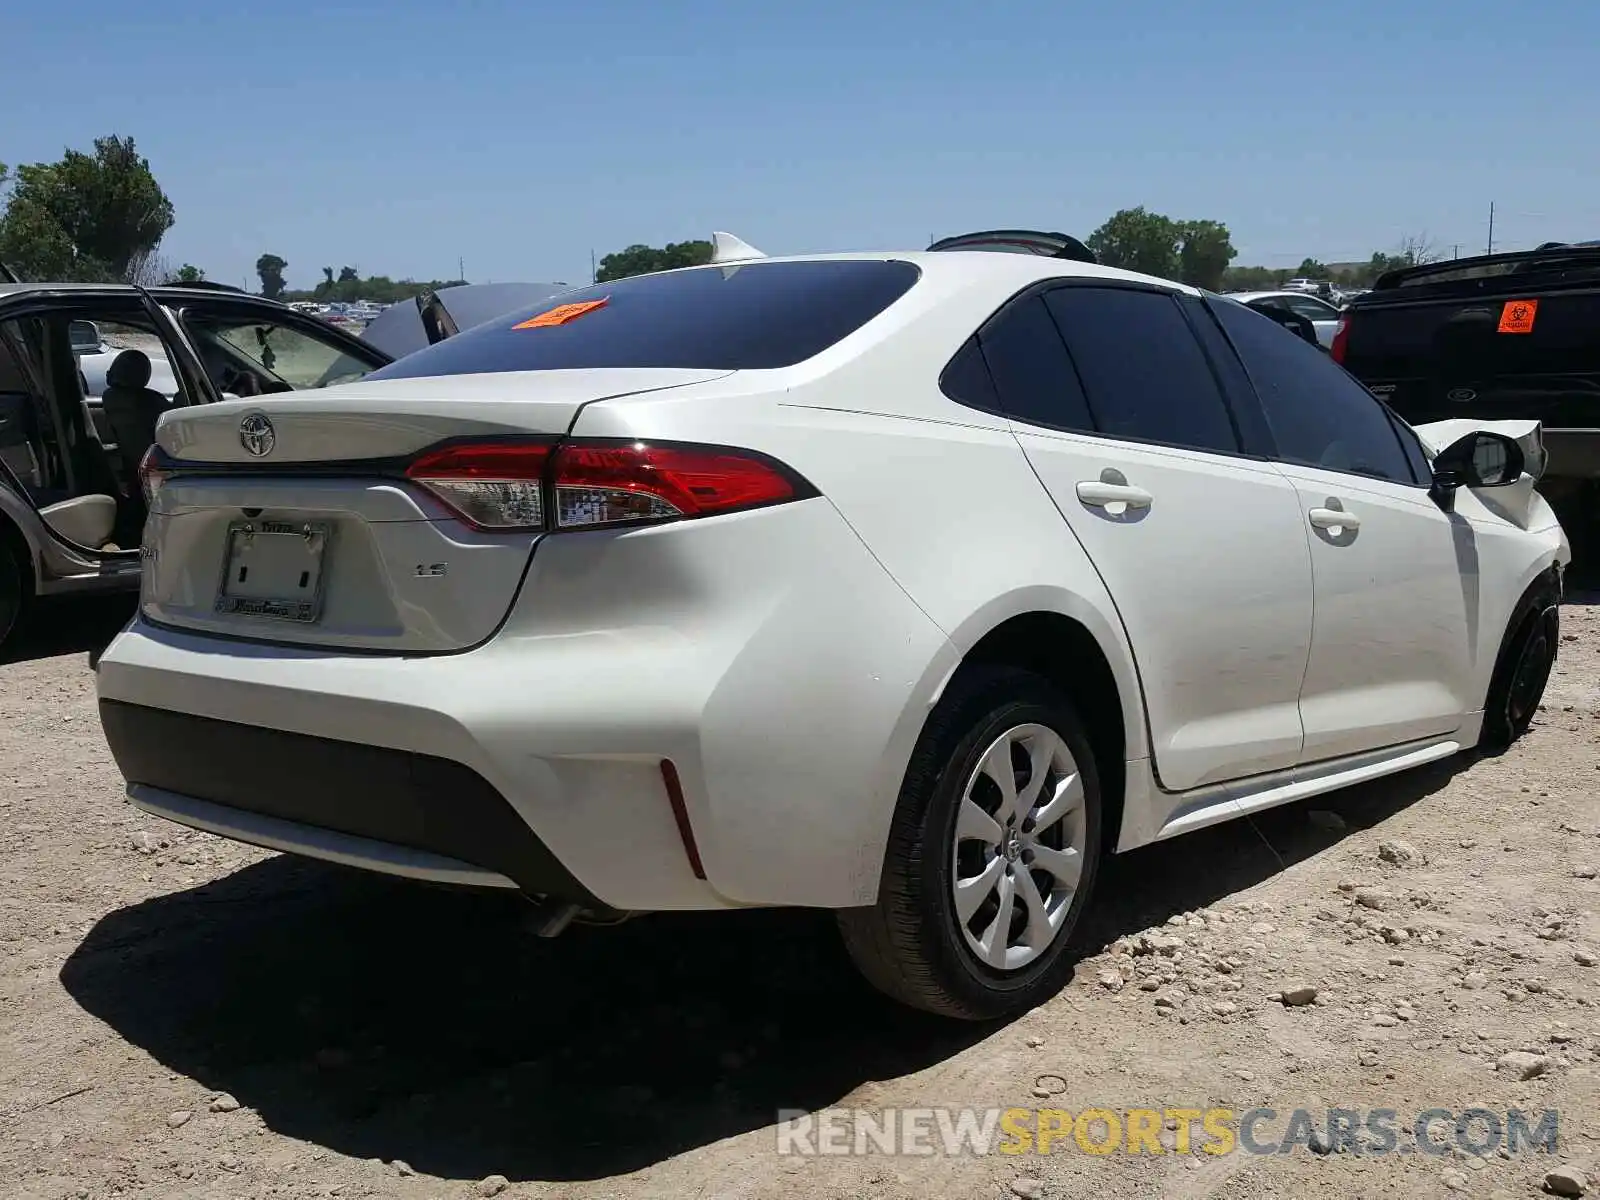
[216,522,328,624]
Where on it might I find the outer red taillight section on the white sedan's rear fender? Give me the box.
[552,442,798,530]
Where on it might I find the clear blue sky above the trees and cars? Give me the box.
[0,0,1600,286]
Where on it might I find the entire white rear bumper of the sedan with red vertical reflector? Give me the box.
[96,501,957,912]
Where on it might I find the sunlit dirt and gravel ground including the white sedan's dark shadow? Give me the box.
[0,605,1600,1200]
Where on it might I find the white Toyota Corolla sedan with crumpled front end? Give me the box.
[99,237,1568,1018]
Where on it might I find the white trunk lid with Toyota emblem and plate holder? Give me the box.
[141,368,730,654]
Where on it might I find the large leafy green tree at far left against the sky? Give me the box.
[0,136,173,282]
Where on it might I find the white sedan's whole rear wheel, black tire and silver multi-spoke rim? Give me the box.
[840,667,1101,1021]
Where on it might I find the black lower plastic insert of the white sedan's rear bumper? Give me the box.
[99,701,605,909]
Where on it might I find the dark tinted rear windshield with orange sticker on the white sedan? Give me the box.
[368,259,918,379]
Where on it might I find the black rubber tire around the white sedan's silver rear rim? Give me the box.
[838,667,1101,1021]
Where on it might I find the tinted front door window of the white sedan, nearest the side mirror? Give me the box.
[1213,299,1414,483]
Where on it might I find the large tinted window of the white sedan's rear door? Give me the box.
[1048,288,1238,453]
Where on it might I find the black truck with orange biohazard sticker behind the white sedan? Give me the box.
[1331,242,1600,566]
